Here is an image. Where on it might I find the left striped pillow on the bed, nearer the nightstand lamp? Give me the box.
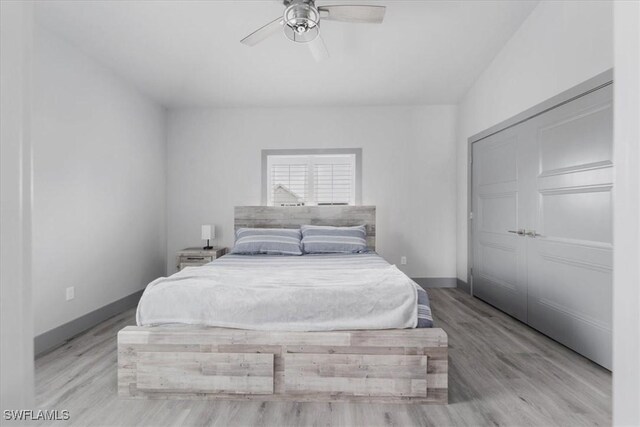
[231,228,302,255]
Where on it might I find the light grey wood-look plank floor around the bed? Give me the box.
[36,289,611,426]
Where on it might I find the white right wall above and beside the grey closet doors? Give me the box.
[456,1,613,281]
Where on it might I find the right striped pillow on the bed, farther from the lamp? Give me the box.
[302,225,367,254]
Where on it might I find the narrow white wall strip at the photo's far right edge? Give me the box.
[613,2,640,427]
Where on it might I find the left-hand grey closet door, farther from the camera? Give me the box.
[472,127,527,321]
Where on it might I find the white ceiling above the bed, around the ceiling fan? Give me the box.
[36,0,537,107]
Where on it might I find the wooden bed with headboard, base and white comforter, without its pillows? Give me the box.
[118,206,448,403]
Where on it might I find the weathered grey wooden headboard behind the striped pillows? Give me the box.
[234,206,376,250]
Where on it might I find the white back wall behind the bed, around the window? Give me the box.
[167,106,456,277]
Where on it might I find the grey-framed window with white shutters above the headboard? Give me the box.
[263,150,361,206]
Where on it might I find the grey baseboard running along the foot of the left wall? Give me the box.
[33,290,142,357]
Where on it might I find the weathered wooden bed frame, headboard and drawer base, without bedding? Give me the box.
[118,206,448,404]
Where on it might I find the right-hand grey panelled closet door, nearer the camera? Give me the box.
[522,85,613,368]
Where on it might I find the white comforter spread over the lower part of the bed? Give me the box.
[136,266,417,331]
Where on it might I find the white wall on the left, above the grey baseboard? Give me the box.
[33,29,166,335]
